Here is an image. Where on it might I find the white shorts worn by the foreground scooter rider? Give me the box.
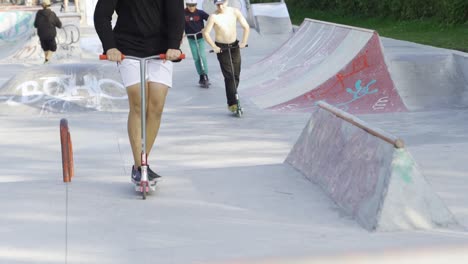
[117,59,173,87]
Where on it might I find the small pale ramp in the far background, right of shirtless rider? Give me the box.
[251,3,293,34]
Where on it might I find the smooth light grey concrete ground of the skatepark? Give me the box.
[0,14,468,264]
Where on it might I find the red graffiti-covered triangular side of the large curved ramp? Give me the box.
[269,34,406,114]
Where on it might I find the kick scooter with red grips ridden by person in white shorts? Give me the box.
[99,54,185,200]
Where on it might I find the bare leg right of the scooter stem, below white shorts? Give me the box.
[146,82,168,155]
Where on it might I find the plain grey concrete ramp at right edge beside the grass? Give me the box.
[382,38,468,111]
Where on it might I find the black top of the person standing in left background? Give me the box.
[34,8,62,40]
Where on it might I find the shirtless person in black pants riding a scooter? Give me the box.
[203,0,250,113]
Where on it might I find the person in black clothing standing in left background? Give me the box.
[34,0,62,63]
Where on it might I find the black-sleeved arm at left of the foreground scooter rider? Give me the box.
[94,0,118,54]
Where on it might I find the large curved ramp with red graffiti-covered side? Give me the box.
[240,19,406,114]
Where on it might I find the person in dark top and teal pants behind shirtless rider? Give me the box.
[185,0,209,84]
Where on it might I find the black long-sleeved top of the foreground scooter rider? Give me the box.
[94,0,185,57]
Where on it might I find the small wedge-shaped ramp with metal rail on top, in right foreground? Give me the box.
[285,102,458,231]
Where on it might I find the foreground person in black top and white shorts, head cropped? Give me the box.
[94,0,185,183]
